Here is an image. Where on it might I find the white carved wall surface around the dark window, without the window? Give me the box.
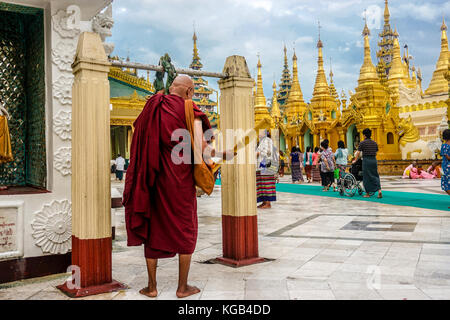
[0,0,111,263]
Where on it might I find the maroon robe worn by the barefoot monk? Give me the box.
[123,94,211,258]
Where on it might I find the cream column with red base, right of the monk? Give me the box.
[217,56,263,266]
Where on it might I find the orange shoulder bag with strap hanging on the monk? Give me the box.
[184,100,216,195]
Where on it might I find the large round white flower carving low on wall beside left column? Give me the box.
[31,200,72,254]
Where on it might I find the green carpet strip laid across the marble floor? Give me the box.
[216,180,450,211]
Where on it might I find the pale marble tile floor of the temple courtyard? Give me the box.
[0,177,450,300]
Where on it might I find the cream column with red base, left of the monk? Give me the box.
[58,32,124,297]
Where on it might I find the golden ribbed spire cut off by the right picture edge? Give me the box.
[425,19,450,95]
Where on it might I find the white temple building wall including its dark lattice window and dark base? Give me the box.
[0,0,111,283]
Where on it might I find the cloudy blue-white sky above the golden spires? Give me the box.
[108,0,450,101]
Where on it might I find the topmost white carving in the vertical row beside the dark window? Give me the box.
[52,6,81,38]
